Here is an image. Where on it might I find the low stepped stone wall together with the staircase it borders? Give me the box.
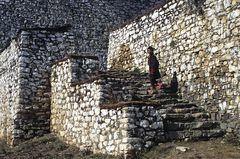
[51,56,223,156]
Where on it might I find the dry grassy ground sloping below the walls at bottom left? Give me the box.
[0,134,116,159]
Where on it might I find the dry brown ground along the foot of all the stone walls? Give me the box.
[0,134,240,159]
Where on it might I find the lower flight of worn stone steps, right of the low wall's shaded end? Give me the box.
[164,103,223,140]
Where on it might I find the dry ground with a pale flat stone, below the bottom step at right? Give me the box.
[142,139,240,159]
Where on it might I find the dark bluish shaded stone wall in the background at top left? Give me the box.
[0,0,163,68]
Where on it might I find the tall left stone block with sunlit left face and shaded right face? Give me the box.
[0,30,74,144]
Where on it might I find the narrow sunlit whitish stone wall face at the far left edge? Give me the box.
[0,40,20,144]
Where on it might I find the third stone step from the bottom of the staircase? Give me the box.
[165,112,209,122]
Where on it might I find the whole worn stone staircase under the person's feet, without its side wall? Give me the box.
[119,71,224,141]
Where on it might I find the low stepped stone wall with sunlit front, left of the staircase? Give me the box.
[51,57,164,155]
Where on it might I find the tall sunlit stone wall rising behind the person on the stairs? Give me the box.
[108,0,239,120]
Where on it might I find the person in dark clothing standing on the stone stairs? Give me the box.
[147,46,161,94]
